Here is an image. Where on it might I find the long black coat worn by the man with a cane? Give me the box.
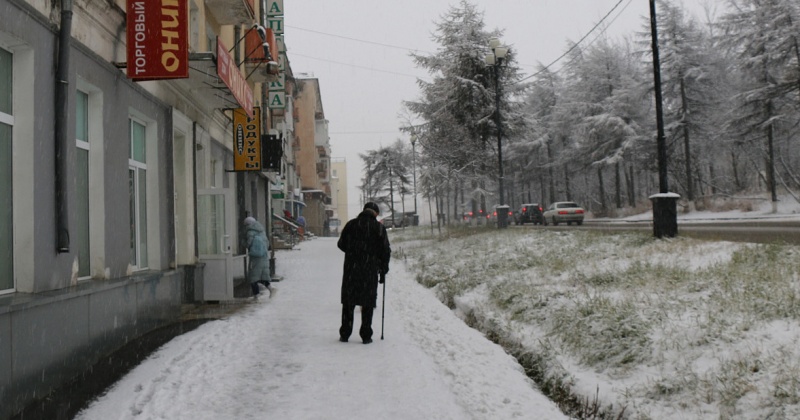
[338,210,392,308]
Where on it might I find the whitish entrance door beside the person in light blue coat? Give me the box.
[197,188,244,301]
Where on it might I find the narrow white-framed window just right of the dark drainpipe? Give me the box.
[75,90,91,278]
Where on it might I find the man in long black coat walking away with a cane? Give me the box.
[337,202,392,344]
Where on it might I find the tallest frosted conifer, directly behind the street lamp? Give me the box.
[405,0,524,217]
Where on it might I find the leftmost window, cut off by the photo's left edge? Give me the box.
[0,48,14,293]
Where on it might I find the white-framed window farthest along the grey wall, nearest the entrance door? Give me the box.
[128,118,147,269]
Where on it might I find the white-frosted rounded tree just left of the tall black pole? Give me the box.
[559,40,647,211]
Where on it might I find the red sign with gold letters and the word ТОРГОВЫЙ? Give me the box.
[127,0,189,81]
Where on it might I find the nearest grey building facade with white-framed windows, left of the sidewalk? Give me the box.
[0,0,299,418]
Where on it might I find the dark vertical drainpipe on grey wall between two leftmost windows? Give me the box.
[55,0,72,254]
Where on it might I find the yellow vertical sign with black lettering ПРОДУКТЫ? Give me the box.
[233,107,261,171]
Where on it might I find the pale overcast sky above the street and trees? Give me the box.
[284,0,722,218]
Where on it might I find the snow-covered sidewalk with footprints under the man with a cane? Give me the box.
[76,238,566,420]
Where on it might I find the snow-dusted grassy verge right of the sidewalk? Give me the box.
[392,229,800,419]
